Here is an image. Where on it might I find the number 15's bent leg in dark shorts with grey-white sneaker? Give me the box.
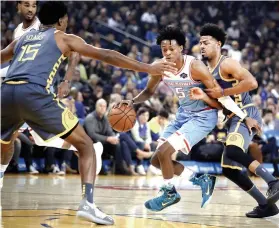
[21,84,114,225]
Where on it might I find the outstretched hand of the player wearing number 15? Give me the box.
[148,61,177,77]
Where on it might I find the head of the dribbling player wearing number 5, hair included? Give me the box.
[157,25,186,62]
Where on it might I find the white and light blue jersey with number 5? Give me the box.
[163,55,209,112]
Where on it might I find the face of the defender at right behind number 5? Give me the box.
[200,36,221,59]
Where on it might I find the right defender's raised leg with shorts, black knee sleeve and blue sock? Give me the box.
[225,107,279,204]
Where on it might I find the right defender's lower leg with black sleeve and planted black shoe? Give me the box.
[223,168,279,218]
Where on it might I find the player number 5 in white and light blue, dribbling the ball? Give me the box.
[117,26,260,211]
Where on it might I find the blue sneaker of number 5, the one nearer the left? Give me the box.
[144,185,181,211]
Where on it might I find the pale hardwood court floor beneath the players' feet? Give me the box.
[2,175,279,228]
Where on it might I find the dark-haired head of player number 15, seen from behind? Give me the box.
[38,1,68,32]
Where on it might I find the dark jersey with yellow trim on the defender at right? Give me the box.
[211,55,253,108]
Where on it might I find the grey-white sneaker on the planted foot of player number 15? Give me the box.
[77,198,114,225]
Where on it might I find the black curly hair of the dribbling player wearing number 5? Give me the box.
[157,25,186,48]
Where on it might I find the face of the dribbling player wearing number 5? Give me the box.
[161,40,183,62]
